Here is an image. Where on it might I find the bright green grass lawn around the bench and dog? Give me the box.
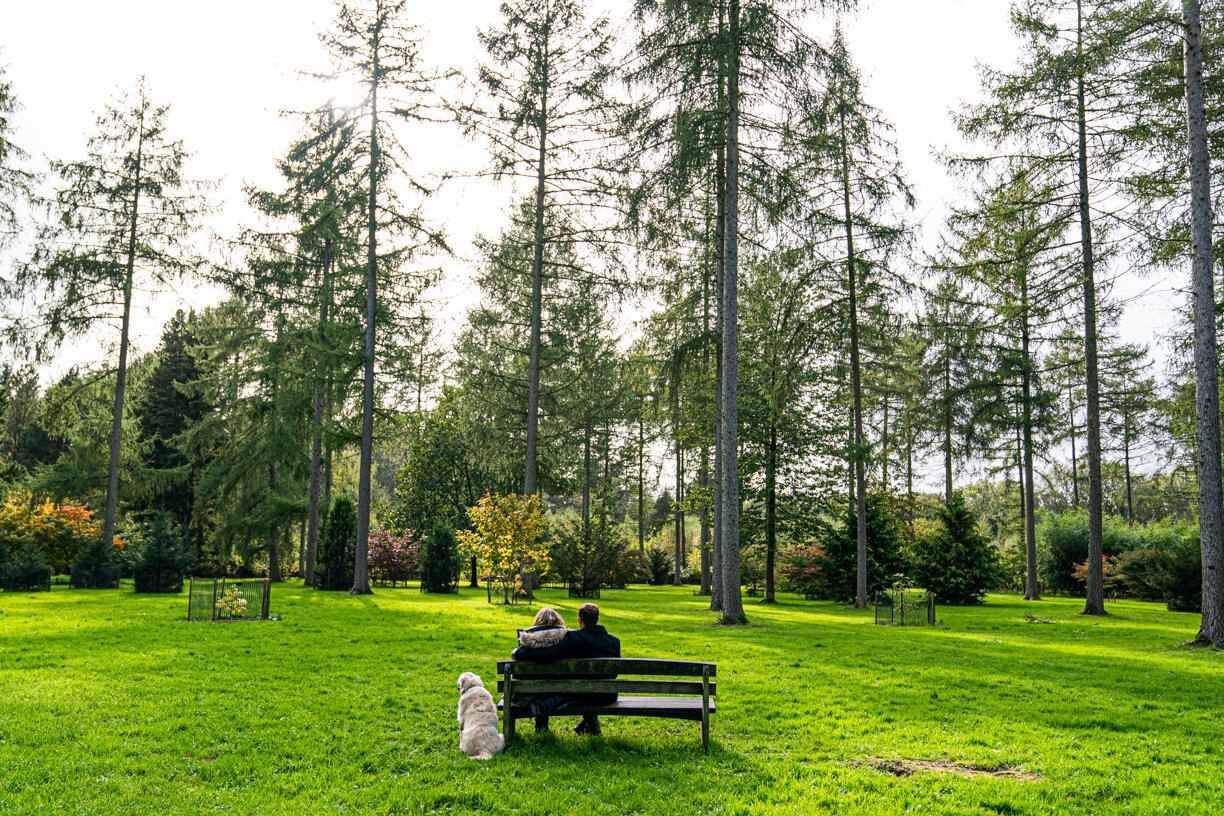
[0,585,1224,816]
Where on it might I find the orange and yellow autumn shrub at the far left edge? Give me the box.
[0,493,124,573]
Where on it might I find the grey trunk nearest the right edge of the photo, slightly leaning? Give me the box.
[1181,0,1224,647]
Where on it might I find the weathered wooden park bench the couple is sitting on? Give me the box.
[497,657,717,751]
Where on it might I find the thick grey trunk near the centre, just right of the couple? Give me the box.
[720,0,748,624]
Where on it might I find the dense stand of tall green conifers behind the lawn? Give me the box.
[0,0,1224,645]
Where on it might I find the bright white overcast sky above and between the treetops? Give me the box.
[0,0,1180,398]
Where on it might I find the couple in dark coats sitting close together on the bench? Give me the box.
[510,603,621,736]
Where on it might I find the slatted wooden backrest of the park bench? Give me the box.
[497,657,717,696]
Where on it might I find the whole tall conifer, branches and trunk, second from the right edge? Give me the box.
[957,0,1149,615]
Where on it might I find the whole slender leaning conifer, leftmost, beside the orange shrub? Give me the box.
[9,80,206,555]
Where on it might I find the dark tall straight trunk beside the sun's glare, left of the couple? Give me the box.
[349,44,379,595]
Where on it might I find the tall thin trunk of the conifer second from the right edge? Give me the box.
[1076,0,1105,615]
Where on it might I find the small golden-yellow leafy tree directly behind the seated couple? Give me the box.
[458,493,548,601]
